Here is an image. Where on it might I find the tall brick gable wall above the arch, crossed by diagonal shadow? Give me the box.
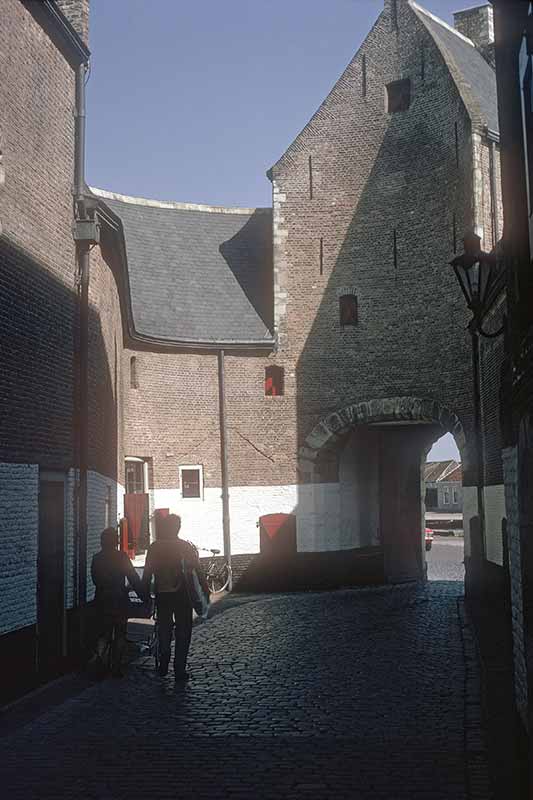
[273,3,473,484]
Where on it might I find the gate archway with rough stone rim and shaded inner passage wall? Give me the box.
[299,396,467,582]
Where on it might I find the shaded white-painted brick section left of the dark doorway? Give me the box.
[0,464,39,634]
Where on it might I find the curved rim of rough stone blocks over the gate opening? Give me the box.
[298,396,466,479]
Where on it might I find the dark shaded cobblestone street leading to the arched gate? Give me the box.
[0,582,489,800]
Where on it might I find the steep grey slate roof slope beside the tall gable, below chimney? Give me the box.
[409,0,499,132]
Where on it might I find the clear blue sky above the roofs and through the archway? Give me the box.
[87,0,464,460]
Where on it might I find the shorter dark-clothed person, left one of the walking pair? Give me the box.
[91,528,143,677]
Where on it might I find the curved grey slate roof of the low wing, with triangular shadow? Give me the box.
[91,189,272,344]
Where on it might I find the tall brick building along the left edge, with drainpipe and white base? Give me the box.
[0,0,123,696]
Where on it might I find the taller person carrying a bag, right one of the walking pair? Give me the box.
[142,514,201,681]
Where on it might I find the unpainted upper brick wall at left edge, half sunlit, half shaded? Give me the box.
[0,0,76,468]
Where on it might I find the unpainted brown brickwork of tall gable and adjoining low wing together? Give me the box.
[123,3,502,546]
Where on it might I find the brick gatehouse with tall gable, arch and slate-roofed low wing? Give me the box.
[93,0,504,579]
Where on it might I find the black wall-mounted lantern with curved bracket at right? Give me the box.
[450,232,505,339]
